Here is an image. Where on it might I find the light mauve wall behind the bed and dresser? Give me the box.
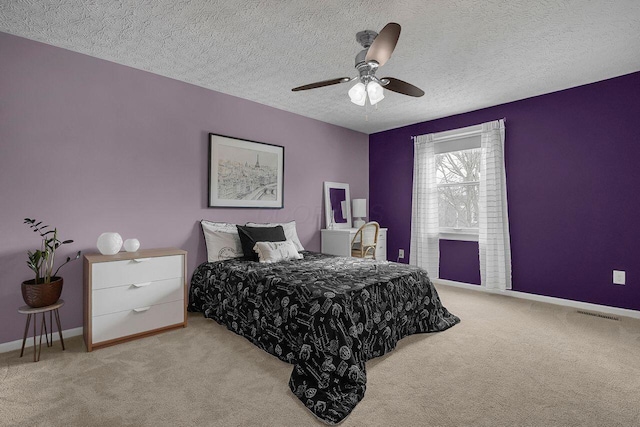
[0,33,369,343]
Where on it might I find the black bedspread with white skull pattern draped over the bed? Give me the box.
[189,251,460,424]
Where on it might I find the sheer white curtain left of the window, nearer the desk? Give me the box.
[409,134,440,279]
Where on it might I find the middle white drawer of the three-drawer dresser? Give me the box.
[91,277,184,317]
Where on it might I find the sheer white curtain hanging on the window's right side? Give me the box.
[478,120,511,290]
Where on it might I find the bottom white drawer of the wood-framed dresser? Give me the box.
[92,300,185,344]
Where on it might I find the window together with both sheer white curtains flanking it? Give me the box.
[409,119,511,290]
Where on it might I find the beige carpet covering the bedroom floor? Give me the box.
[0,286,640,426]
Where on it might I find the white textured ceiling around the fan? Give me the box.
[0,0,640,133]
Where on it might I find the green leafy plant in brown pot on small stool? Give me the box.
[22,218,80,308]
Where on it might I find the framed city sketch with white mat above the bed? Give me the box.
[209,133,284,209]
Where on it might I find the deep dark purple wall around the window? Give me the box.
[369,72,640,310]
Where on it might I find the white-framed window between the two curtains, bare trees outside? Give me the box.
[433,126,482,241]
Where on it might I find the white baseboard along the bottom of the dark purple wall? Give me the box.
[433,279,640,319]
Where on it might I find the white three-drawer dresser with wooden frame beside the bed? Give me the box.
[84,248,187,351]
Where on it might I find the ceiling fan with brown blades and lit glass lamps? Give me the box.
[291,22,424,105]
